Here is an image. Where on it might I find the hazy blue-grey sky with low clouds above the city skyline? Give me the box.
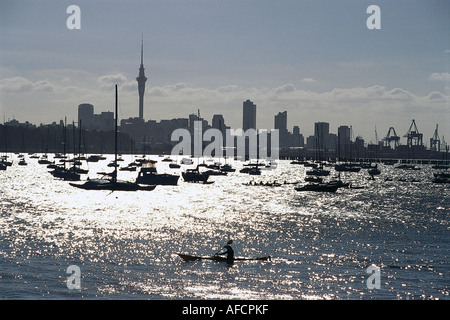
[0,0,450,144]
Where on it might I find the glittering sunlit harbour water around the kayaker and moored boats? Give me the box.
[0,154,450,300]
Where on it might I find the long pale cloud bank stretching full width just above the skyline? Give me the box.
[0,73,450,141]
